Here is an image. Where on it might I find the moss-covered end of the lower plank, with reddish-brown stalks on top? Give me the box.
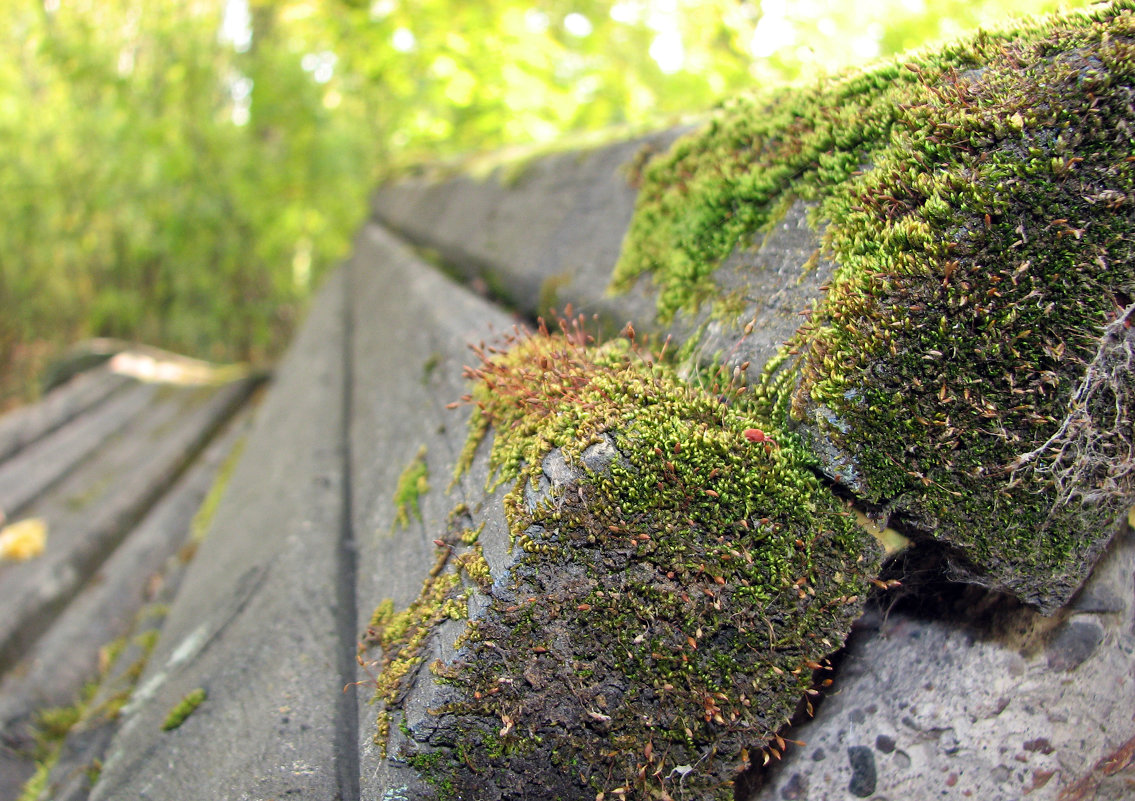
[369,327,882,801]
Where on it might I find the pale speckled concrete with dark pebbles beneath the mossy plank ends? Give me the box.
[749,517,1135,801]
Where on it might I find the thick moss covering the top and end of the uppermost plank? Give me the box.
[614,0,1135,610]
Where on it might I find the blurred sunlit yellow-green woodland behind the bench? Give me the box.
[0,0,1086,410]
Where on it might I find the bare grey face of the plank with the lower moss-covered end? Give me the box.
[351,226,512,801]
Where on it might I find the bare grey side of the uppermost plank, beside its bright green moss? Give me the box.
[372,128,834,390]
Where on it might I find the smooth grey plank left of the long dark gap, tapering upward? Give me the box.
[92,272,354,799]
